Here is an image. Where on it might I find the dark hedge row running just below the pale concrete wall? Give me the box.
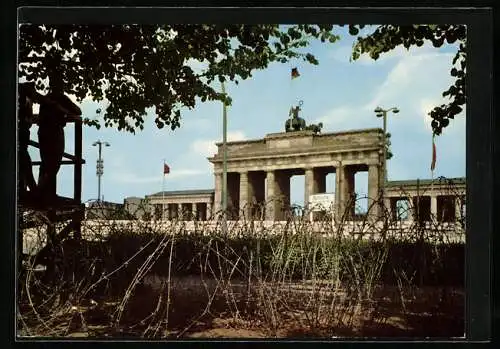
[53,232,465,287]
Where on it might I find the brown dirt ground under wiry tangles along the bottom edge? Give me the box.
[19,277,465,339]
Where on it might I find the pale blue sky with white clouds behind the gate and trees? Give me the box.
[26,28,465,204]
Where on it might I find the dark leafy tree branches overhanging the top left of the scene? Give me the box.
[19,24,339,133]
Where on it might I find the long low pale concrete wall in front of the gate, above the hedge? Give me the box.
[23,220,465,254]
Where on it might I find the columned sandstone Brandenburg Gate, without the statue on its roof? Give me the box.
[208,128,384,221]
